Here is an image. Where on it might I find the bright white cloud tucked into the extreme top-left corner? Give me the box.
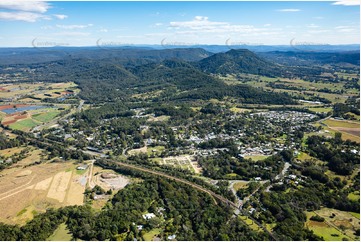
[0,0,51,13]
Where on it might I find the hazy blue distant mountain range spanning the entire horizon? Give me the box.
[0,45,360,64]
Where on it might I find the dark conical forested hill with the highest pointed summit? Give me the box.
[197,49,281,76]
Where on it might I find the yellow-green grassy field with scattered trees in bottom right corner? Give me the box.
[306,208,360,241]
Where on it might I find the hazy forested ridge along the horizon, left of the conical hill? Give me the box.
[0,46,213,65]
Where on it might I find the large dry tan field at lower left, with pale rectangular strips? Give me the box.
[0,157,87,224]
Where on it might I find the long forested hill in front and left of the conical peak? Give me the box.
[129,60,293,104]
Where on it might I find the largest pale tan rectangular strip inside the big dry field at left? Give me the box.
[47,171,72,202]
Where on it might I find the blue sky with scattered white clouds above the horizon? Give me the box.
[0,0,360,47]
